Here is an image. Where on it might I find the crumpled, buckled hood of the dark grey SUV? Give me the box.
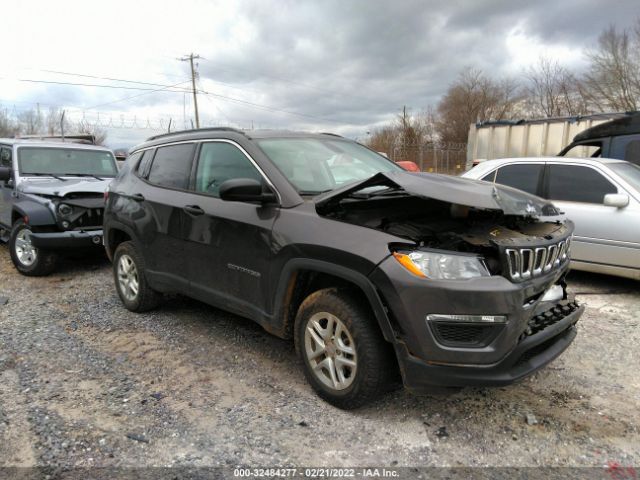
[315,172,559,217]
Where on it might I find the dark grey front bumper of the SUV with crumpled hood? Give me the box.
[370,255,584,390]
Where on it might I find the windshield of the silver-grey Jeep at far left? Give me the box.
[18,147,118,177]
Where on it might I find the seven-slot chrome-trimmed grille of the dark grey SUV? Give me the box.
[505,238,571,281]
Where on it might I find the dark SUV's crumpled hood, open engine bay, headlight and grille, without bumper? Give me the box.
[316,172,573,282]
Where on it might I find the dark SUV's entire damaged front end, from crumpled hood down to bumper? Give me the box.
[316,172,584,389]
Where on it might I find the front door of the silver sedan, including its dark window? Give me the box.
[544,162,640,268]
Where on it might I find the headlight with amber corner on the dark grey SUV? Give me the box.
[393,250,491,280]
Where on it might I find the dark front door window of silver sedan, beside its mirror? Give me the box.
[548,165,618,203]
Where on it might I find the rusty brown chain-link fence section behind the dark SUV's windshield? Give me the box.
[388,143,467,175]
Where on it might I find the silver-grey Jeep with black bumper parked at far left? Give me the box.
[0,139,117,276]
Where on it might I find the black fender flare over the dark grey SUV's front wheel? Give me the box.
[274,258,396,343]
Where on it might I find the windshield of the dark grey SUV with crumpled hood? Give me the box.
[258,138,403,195]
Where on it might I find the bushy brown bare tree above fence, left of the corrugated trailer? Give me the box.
[437,68,522,143]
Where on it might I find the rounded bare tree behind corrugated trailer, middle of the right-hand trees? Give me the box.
[525,57,588,117]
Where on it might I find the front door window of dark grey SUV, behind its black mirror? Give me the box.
[195,142,262,197]
